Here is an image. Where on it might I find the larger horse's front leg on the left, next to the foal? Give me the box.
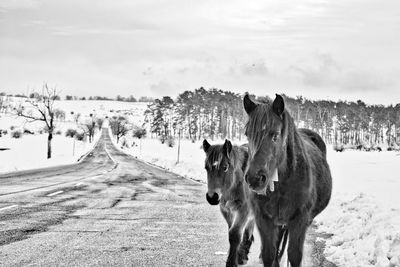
[256,218,279,267]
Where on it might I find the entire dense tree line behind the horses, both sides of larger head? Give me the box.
[145,87,400,146]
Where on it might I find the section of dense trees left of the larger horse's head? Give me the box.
[145,87,245,141]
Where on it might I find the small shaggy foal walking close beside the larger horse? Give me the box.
[203,140,254,266]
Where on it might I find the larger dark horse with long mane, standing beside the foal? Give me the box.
[243,95,332,267]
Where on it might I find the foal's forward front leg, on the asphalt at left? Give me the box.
[226,211,247,266]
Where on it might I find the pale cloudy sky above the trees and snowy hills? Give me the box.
[0,0,400,104]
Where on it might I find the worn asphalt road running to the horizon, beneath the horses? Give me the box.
[0,130,333,266]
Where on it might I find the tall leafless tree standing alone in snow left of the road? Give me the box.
[17,84,59,159]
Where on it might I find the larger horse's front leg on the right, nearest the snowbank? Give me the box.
[288,216,308,267]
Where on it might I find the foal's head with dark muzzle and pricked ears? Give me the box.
[203,139,233,205]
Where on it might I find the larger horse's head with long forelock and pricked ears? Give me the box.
[243,95,286,194]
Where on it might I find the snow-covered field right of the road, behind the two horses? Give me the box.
[117,139,400,267]
